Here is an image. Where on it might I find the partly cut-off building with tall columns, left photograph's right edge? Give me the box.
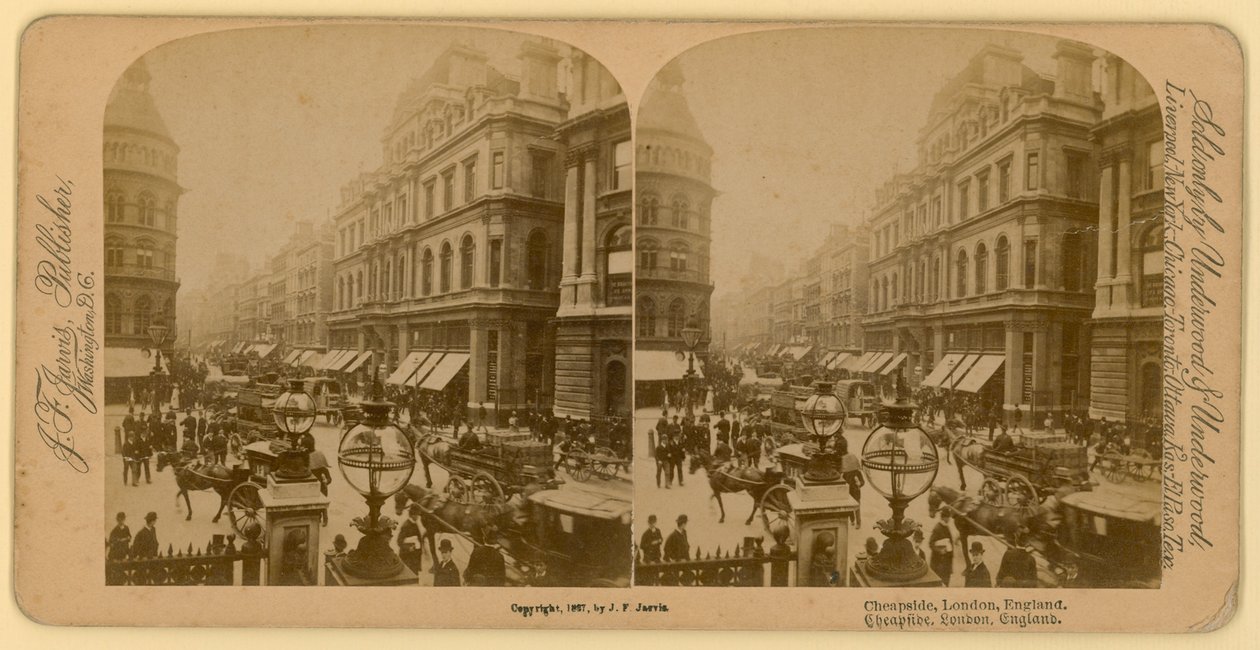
[553,52,634,419]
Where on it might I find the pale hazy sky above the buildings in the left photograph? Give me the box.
[145,25,551,291]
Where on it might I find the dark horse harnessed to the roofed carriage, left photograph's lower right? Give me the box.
[394,484,527,569]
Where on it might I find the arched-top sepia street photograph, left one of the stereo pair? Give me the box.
[102,25,634,587]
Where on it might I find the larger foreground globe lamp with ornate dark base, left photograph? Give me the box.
[336,402,416,579]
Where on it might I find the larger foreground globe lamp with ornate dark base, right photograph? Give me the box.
[862,375,940,582]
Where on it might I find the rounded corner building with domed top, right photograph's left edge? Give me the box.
[635,62,714,393]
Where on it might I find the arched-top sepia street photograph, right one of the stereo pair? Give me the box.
[634,28,1164,588]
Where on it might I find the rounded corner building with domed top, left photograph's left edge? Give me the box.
[102,59,184,401]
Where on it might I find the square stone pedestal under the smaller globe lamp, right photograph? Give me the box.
[788,480,858,587]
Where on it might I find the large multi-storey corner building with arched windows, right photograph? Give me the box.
[863,42,1103,423]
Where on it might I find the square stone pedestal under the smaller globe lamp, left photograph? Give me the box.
[258,476,329,586]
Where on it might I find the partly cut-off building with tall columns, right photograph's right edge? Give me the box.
[1089,55,1164,421]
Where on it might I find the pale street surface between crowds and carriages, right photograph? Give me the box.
[634,408,1159,587]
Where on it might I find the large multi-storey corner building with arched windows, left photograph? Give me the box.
[328,42,567,417]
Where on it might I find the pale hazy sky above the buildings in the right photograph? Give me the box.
[679,28,1055,294]
